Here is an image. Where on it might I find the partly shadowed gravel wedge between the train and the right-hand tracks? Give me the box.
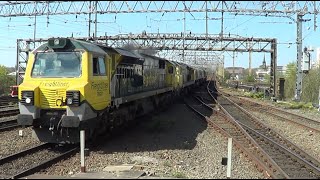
[41,104,264,179]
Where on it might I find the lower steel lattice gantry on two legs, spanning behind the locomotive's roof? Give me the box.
[17,33,277,96]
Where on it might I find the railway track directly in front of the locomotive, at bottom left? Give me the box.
[0,143,79,179]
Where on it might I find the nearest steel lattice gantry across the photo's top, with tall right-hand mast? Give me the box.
[4,1,320,100]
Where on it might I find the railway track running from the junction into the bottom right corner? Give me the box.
[217,92,320,179]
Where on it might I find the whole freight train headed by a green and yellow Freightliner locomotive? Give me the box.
[18,38,205,143]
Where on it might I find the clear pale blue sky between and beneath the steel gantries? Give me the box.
[0,2,320,68]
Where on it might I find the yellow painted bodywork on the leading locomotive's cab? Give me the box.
[19,52,111,110]
